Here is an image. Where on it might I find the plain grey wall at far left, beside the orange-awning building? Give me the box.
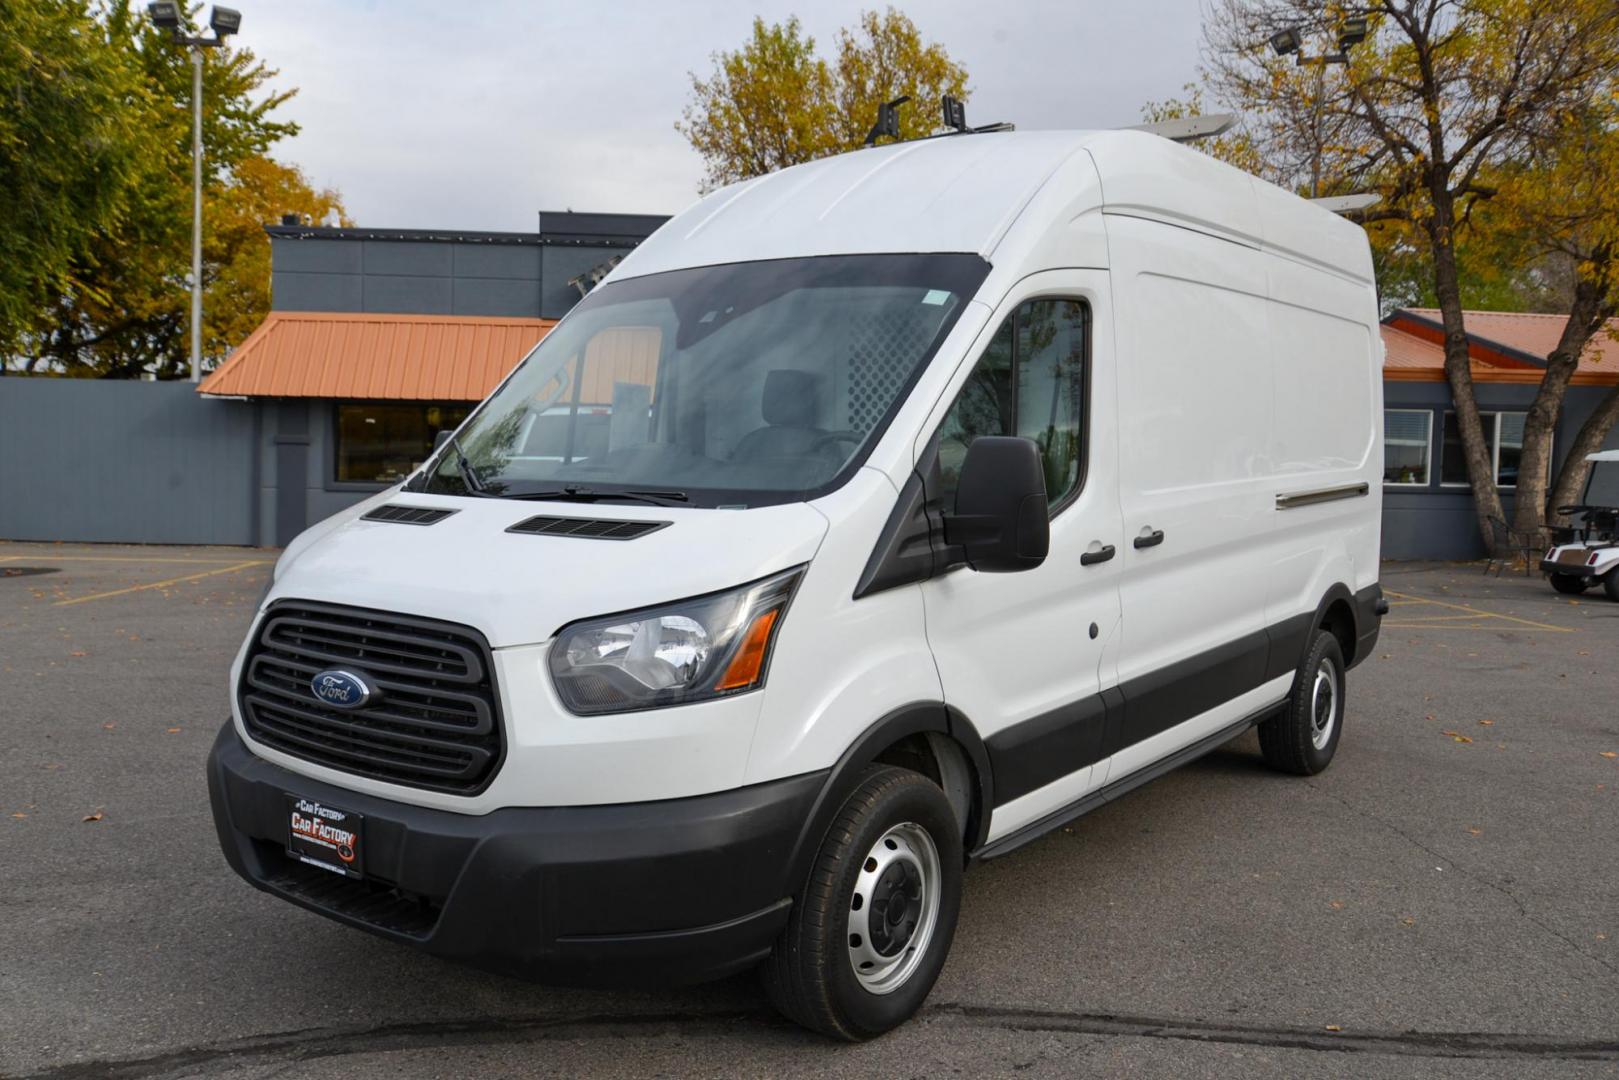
[0,377,257,544]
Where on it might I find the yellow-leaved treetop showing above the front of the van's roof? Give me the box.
[675,8,968,191]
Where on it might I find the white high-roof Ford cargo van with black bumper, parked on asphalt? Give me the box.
[209,131,1384,1040]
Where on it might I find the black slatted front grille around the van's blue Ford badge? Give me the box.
[240,601,502,795]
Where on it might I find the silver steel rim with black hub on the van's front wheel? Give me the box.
[848,821,944,994]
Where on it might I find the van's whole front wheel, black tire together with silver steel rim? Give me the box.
[763,766,962,1041]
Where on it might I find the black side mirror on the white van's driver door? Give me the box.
[944,436,1051,573]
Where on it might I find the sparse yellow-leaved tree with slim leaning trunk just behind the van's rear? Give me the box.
[1205,0,1619,553]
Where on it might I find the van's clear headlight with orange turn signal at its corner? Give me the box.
[550,567,803,714]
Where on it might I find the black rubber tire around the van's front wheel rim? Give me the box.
[761,766,963,1043]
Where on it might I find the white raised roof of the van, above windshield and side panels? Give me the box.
[614,131,1371,283]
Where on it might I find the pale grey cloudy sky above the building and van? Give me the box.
[236,0,1198,232]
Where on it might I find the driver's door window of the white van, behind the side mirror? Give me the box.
[934,300,1090,512]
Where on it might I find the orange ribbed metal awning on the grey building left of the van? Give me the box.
[198,311,557,402]
